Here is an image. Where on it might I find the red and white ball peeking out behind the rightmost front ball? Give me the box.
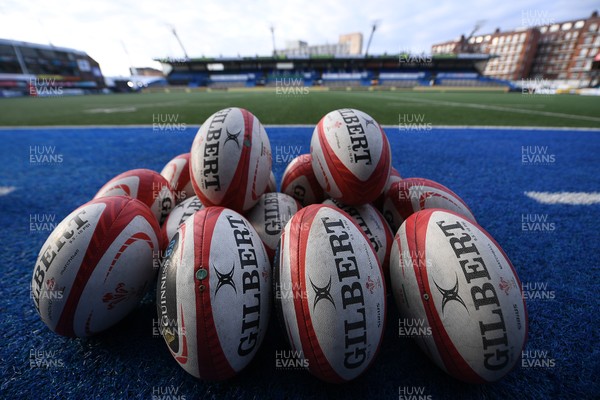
[383,178,475,233]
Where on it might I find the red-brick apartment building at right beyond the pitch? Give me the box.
[431,11,600,86]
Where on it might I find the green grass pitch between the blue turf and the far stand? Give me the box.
[0,88,600,128]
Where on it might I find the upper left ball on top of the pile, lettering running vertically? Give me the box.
[190,108,272,212]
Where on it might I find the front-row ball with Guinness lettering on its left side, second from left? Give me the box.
[156,207,272,380]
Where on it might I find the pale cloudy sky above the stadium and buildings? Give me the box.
[0,0,600,76]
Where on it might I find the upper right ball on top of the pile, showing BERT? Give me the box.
[310,108,392,205]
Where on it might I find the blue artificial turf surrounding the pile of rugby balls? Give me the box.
[0,127,600,400]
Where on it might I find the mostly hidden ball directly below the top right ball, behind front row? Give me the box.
[323,199,394,280]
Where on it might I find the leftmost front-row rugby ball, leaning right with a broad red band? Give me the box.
[31,196,162,337]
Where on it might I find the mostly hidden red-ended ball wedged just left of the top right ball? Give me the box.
[281,154,325,206]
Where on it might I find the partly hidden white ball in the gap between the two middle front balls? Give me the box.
[246,193,302,261]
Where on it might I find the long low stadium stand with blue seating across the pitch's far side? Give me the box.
[157,54,511,90]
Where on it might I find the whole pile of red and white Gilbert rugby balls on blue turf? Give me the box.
[32,108,527,383]
